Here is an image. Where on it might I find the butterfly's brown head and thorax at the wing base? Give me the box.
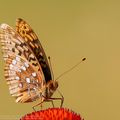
[46,80,58,98]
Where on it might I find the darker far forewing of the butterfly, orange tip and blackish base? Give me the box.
[16,18,52,83]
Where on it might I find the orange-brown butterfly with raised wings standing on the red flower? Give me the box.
[0,18,64,110]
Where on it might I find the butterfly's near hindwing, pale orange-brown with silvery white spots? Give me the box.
[5,56,44,103]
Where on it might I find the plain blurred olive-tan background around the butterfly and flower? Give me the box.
[0,0,120,120]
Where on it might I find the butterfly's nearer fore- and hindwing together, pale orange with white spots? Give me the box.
[0,24,45,103]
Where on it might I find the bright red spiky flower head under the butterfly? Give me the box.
[20,108,84,120]
